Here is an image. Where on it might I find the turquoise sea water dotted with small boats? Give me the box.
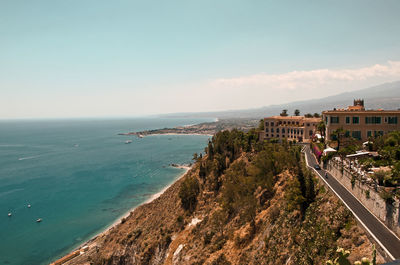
[0,118,209,265]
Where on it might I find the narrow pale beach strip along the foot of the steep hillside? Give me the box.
[49,165,193,265]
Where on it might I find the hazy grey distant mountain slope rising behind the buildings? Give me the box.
[163,81,400,118]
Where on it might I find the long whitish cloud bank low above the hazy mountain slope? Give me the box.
[205,61,400,109]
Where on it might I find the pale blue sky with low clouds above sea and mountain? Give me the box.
[0,0,400,119]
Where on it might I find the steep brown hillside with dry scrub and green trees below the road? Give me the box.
[68,130,383,265]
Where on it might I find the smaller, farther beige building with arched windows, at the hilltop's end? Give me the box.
[260,116,321,142]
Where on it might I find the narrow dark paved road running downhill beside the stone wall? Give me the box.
[304,145,400,260]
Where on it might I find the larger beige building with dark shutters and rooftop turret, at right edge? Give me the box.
[322,99,400,141]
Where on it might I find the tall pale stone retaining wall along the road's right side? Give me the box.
[326,161,400,236]
